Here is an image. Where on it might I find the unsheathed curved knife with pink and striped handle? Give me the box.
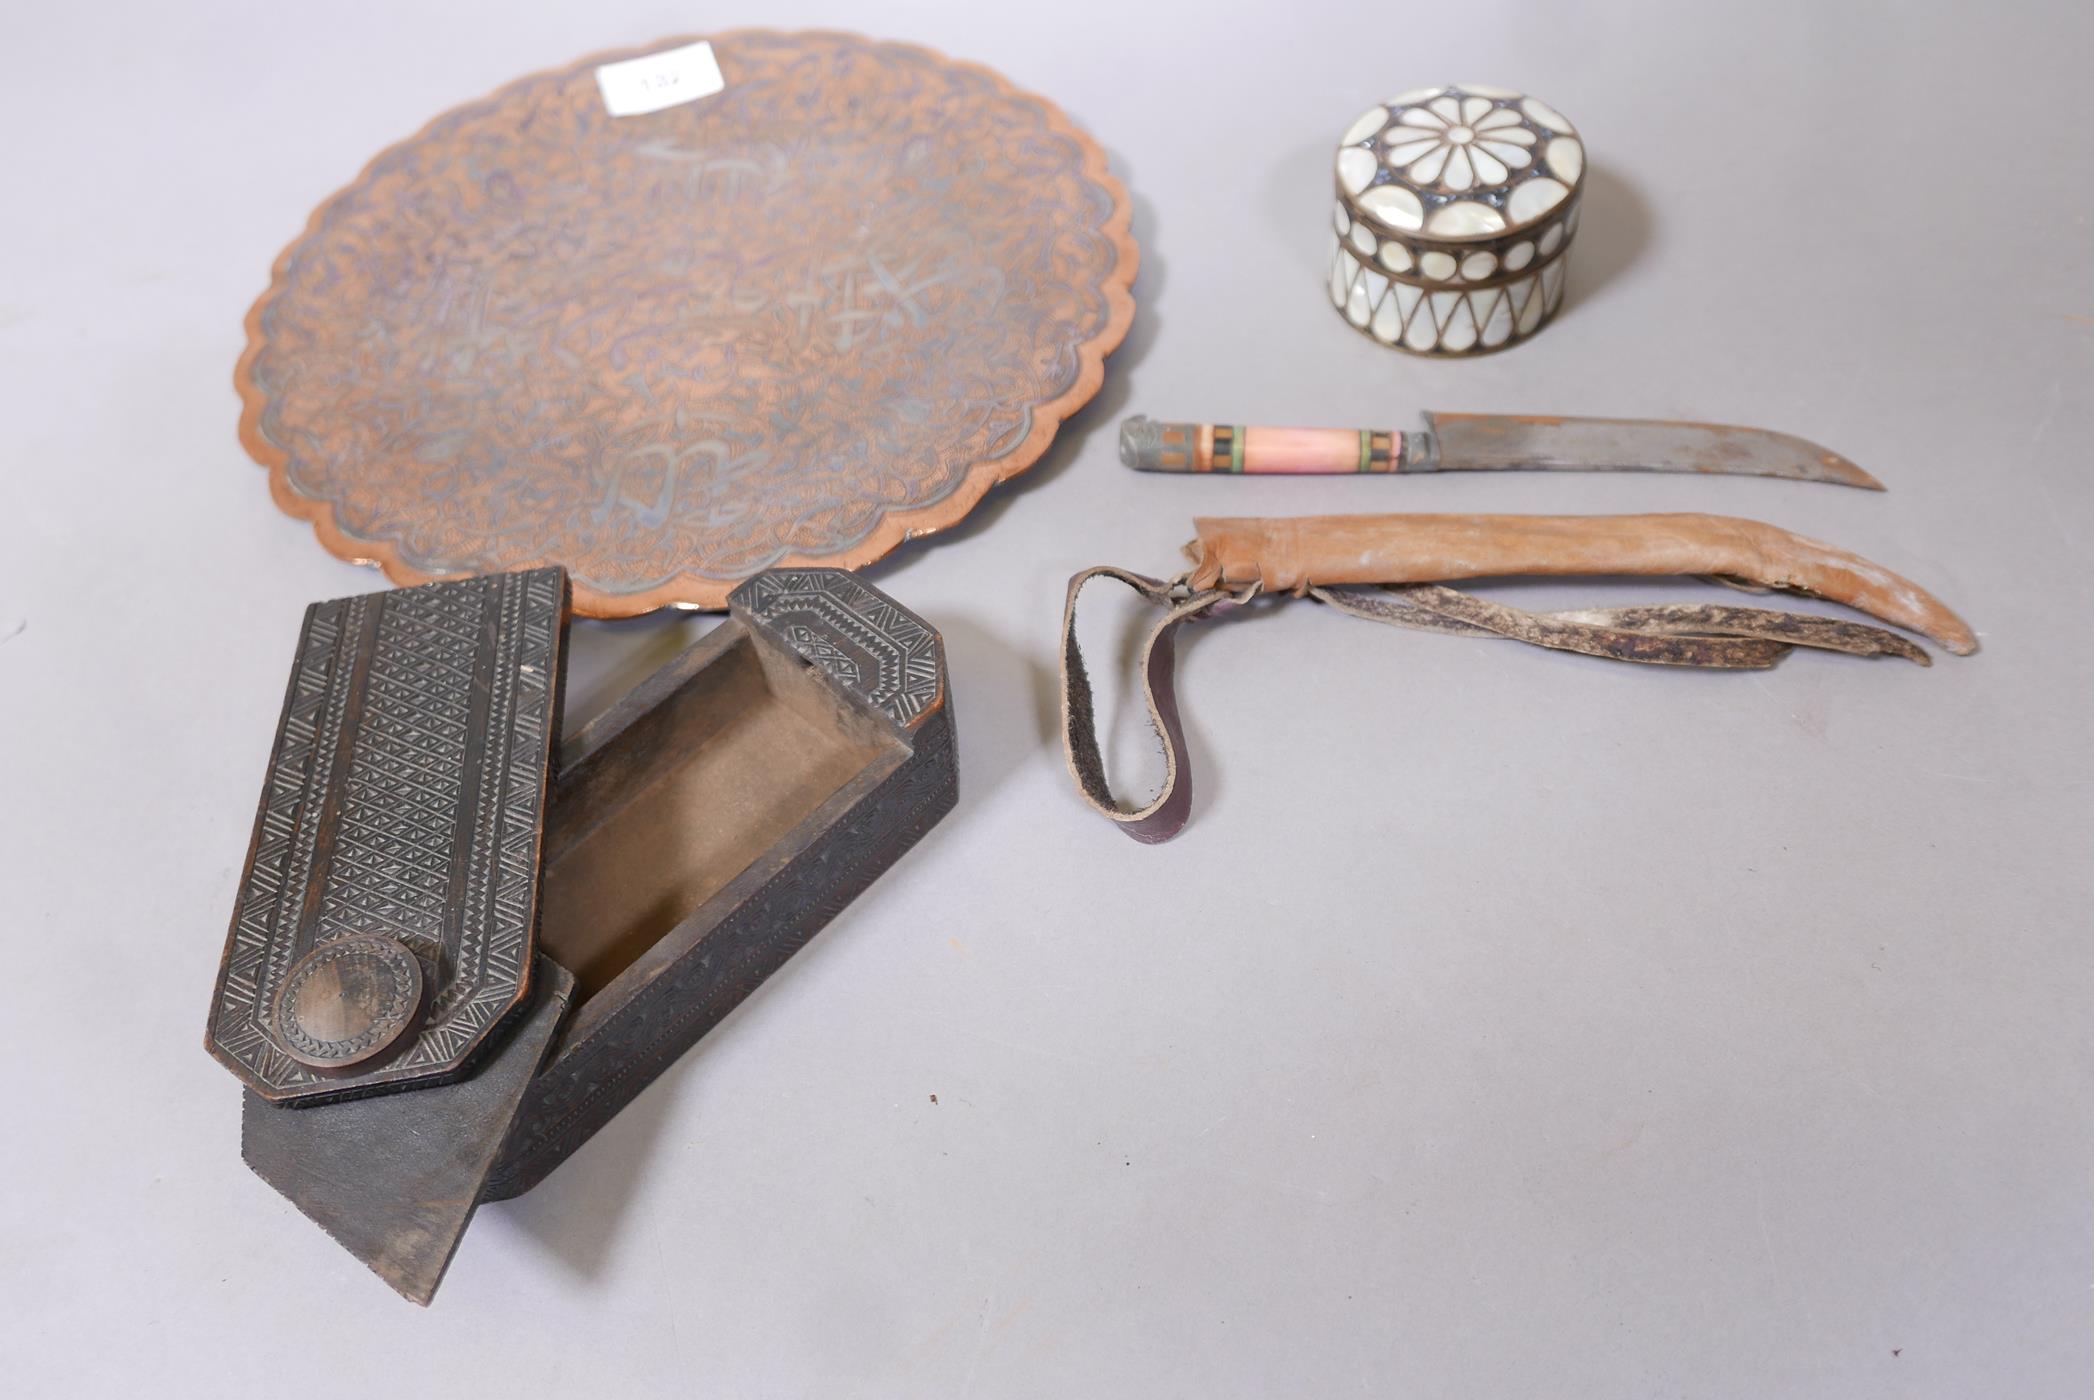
[1120,412,1883,492]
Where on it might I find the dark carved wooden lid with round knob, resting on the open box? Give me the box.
[205,569,567,1103]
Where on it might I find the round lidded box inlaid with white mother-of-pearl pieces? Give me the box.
[1330,84,1585,356]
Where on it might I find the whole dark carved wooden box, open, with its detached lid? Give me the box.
[205,569,957,1302]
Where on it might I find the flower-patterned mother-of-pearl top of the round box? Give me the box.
[1336,84,1585,241]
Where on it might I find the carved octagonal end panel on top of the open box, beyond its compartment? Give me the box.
[729,569,944,728]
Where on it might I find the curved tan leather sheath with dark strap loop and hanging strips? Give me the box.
[1062,515,1977,843]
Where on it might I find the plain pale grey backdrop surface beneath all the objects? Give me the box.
[0,0,2094,1400]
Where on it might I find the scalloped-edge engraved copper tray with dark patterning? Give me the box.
[235,31,1137,617]
